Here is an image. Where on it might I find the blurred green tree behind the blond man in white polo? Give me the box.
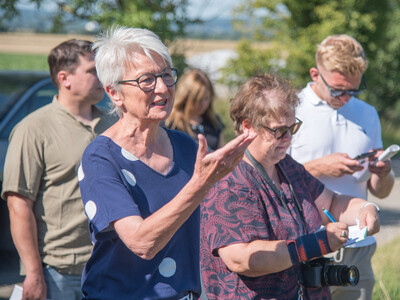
[222,0,400,123]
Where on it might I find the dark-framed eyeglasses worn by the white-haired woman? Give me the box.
[118,68,178,92]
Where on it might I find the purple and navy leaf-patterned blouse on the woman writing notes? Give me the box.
[200,155,330,300]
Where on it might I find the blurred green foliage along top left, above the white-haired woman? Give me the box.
[0,0,201,70]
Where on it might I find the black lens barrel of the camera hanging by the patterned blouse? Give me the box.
[323,265,360,286]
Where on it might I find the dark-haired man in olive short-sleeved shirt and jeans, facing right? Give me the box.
[2,39,112,300]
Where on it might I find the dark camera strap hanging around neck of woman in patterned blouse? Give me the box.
[245,149,307,231]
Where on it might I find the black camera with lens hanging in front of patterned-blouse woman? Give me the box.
[301,257,360,287]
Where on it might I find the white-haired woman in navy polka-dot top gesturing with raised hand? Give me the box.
[78,27,255,299]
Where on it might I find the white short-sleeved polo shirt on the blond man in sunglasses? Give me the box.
[288,82,382,246]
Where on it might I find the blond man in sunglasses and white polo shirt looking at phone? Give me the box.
[288,35,394,299]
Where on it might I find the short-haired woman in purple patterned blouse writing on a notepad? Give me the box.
[200,75,379,300]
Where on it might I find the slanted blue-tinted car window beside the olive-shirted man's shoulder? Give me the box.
[0,83,57,139]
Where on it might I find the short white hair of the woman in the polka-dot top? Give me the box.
[93,25,173,114]
